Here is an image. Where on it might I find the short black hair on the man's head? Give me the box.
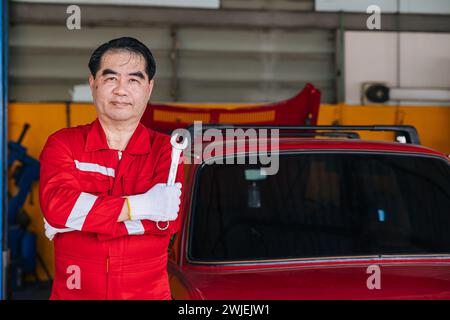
[88,37,156,80]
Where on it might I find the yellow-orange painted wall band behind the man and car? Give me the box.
[8,103,450,279]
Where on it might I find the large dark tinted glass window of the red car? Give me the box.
[189,152,450,261]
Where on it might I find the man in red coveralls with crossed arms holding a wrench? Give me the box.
[39,37,183,299]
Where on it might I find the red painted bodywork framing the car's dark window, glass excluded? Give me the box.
[168,137,450,300]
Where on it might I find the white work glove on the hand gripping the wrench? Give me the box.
[127,182,181,222]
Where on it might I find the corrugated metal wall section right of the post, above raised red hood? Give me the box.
[179,29,335,102]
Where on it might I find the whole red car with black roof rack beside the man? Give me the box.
[168,126,450,299]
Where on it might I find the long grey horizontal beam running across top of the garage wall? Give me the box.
[10,2,450,32]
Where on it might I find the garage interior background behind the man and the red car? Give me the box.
[0,0,450,299]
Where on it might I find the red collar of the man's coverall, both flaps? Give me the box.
[84,119,150,154]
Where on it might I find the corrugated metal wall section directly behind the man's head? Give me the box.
[10,25,171,101]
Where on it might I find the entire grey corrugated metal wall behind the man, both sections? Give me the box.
[10,0,336,103]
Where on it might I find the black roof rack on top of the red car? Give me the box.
[182,123,420,144]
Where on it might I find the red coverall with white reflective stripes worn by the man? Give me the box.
[39,120,183,299]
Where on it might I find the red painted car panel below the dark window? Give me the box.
[175,264,450,300]
